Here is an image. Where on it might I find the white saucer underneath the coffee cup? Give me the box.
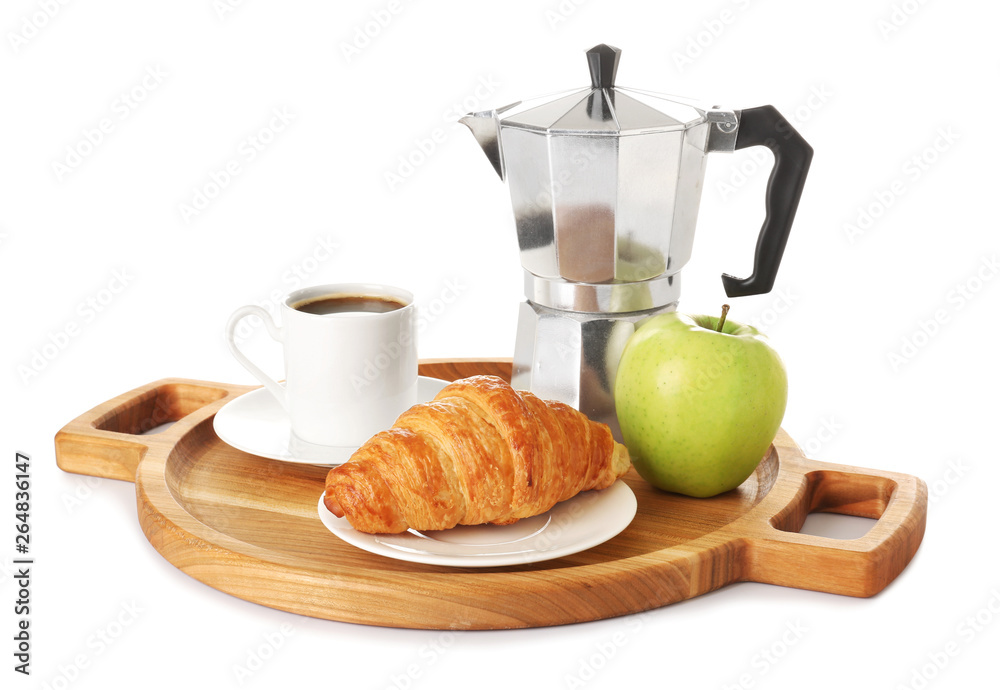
[213,376,448,465]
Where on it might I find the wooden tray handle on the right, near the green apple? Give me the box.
[743,460,927,597]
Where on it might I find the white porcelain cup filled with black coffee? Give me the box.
[226,283,417,446]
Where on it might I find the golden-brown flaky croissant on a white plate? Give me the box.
[323,376,631,533]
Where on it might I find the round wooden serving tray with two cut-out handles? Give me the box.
[55,360,927,629]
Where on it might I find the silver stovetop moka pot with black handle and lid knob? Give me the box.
[461,44,812,439]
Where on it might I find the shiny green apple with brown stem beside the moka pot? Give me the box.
[614,308,788,497]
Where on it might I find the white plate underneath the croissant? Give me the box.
[319,480,636,568]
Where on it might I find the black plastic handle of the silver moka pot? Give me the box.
[722,105,813,297]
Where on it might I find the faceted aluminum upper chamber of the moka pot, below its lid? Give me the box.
[508,122,709,312]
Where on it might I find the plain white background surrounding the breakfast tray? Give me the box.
[0,0,1000,688]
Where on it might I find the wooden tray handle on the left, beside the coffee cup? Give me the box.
[55,379,253,482]
